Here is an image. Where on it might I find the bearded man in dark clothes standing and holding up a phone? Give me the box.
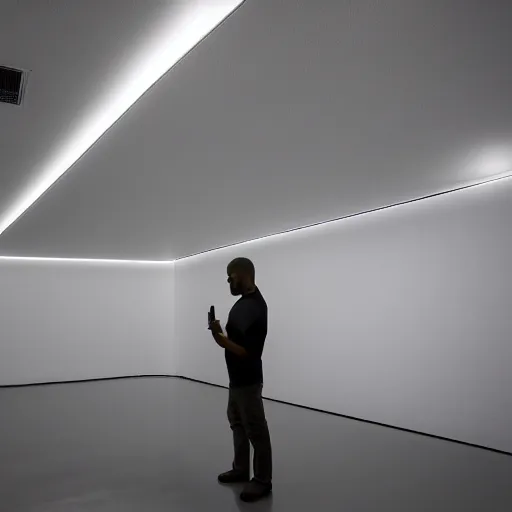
[209,258,272,501]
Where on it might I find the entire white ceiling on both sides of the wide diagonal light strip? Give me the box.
[0,0,512,260]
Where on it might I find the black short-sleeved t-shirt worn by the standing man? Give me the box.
[225,288,268,387]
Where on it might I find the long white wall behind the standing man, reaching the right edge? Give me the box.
[176,180,512,451]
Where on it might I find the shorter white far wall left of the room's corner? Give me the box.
[0,260,176,385]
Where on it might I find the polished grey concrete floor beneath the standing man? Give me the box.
[0,379,512,512]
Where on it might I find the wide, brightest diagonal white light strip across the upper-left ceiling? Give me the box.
[0,0,243,234]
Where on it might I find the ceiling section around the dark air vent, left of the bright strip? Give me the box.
[0,0,180,224]
